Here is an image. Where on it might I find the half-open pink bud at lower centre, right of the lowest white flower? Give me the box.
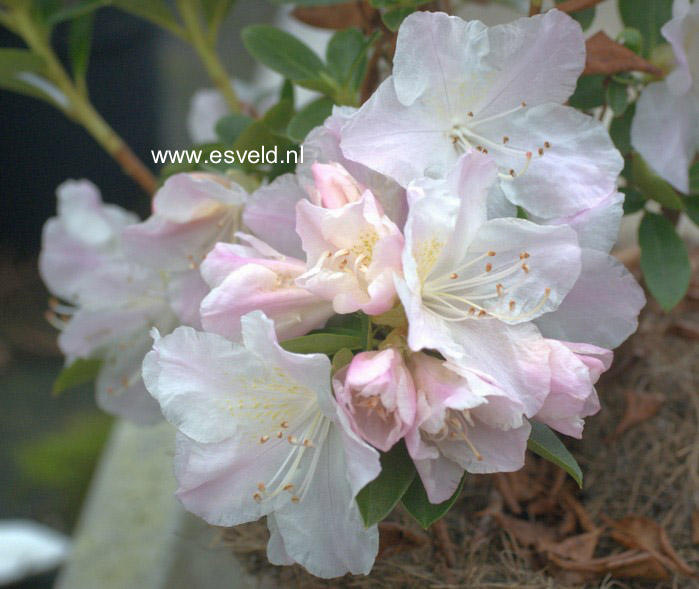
[333,348,415,452]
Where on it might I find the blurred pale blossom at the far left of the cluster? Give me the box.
[39,180,178,423]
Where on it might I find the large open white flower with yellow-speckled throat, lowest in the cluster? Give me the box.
[143,311,380,577]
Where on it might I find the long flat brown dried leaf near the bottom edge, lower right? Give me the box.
[549,550,670,581]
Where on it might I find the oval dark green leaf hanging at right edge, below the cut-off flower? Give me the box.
[638,212,692,311]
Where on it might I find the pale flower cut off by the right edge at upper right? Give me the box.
[631,0,699,194]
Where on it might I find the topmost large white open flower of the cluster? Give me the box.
[341,10,623,217]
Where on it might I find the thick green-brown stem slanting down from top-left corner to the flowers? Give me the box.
[7,5,157,194]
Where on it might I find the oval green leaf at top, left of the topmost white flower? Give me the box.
[241,25,325,82]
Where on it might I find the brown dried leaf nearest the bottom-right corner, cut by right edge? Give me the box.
[607,515,697,578]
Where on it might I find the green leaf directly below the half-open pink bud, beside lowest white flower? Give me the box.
[357,440,415,528]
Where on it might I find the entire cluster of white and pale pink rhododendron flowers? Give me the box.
[42,11,645,577]
